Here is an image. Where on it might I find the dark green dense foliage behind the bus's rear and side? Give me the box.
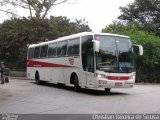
[0,16,91,69]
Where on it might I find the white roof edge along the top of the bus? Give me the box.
[29,32,129,47]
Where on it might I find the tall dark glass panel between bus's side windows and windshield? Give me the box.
[82,35,94,73]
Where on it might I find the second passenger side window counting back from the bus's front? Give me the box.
[57,41,67,56]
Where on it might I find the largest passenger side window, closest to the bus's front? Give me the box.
[68,38,80,55]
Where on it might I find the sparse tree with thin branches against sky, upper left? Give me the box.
[0,0,67,19]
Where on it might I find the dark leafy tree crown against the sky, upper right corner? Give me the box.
[118,0,160,35]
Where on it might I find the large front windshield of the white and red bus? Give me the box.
[95,35,134,73]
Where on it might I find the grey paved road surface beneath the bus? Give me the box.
[0,79,160,114]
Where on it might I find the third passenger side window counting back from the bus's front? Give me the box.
[48,43,57,57]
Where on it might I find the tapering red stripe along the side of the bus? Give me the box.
[27,60,75,67]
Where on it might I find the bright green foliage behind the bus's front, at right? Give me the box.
[102,22,160,82]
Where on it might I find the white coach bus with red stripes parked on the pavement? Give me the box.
[27,32,143,92]
